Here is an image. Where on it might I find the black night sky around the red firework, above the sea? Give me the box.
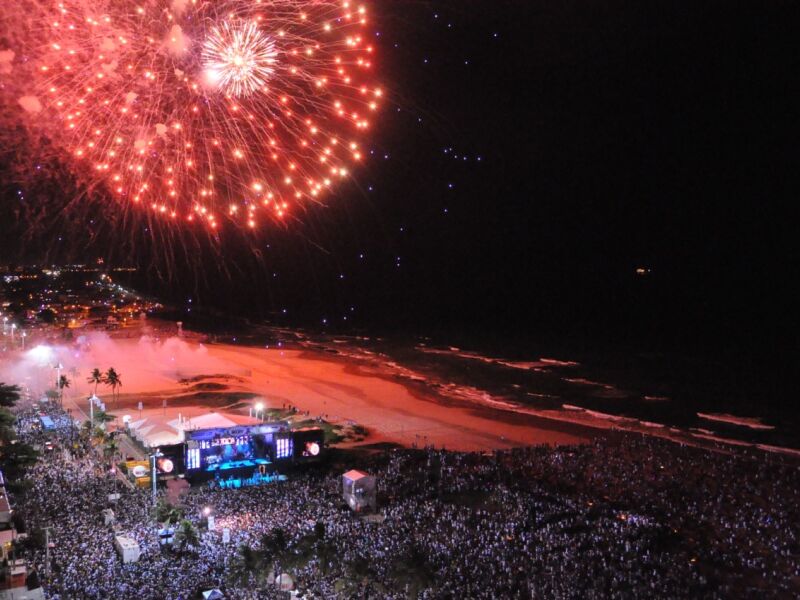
[3,0,800,360]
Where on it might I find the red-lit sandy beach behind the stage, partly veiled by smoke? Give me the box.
[18,332,588,451]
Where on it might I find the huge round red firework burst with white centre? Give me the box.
[0,0,383,230]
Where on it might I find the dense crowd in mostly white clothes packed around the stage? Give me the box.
[7,404,800,600]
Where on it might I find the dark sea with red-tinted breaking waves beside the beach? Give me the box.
[152,304,800,457]
